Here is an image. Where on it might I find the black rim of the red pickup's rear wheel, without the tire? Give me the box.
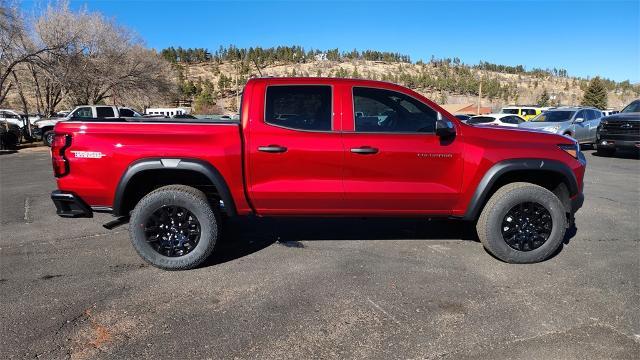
[144,205,200,257]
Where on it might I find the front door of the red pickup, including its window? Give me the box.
[342,87,462,215]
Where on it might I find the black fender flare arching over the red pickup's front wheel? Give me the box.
[462,159,579,221]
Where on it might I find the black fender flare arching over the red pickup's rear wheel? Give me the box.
[113,158,237,216]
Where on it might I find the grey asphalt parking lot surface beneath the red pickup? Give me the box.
[0,148,640,359]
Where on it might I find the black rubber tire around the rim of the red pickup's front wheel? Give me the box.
[476,182,567,264]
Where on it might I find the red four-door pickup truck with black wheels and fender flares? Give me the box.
[52,78,586,270]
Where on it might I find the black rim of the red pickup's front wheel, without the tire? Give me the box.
[501,202,553,251]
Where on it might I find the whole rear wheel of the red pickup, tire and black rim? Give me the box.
[129,185,219,270]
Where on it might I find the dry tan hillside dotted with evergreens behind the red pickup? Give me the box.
[163,47,640,112]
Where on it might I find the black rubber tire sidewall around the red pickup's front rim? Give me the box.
[486,187,566,263]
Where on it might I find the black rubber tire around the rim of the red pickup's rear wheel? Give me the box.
[129,185,220,270]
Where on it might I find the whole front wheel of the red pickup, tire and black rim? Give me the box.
[476,182,567,264]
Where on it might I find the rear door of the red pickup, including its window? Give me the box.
[245,80,344,215]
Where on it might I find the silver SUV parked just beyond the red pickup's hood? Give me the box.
[518,107,602,144]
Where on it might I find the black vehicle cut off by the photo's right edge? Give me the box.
[596,99,640,156]
